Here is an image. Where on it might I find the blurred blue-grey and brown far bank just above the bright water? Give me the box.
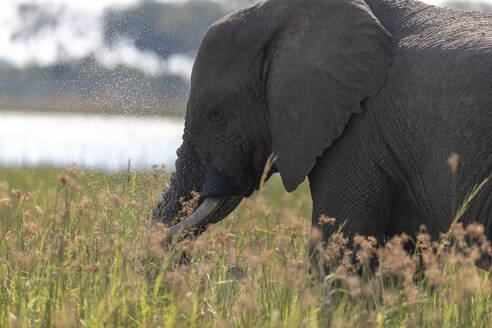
[0,57,189,116]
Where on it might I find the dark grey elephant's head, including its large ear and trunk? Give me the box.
[153,0,392,236]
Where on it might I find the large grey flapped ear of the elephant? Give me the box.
[238,0,392,191]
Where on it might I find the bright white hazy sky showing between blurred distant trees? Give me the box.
[0,0,492,78]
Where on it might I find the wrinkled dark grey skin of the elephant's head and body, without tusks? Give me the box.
[153,0,492,266]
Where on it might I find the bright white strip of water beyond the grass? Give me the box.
[0,111,184,171]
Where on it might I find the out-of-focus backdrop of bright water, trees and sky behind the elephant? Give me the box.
[0,0,492,171]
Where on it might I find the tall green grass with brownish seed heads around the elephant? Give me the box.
[0,168,492,328]
